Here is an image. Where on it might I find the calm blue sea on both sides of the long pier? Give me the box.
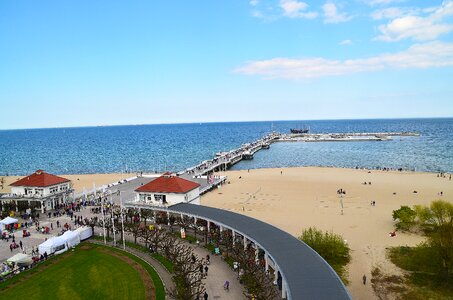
[0,118,453,175]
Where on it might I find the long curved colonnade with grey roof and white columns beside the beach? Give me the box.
[126,202,351,300]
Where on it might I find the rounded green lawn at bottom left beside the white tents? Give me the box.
[0,243,165,299]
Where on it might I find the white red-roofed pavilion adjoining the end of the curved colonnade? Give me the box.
[135,173,200,206]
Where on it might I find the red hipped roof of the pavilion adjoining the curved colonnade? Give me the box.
[135,175,200,194]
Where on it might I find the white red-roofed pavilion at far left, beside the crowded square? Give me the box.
[0,170,72,213]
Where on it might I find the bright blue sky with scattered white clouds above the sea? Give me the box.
[0,0,453,129]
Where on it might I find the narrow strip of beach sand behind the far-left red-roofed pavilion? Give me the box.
[0,173,131,193]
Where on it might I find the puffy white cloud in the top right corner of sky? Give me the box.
[376,1,453,42]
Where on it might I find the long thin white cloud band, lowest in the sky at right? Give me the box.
[235,42,453,80]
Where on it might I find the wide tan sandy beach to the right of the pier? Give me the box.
[201,167,453,299]
